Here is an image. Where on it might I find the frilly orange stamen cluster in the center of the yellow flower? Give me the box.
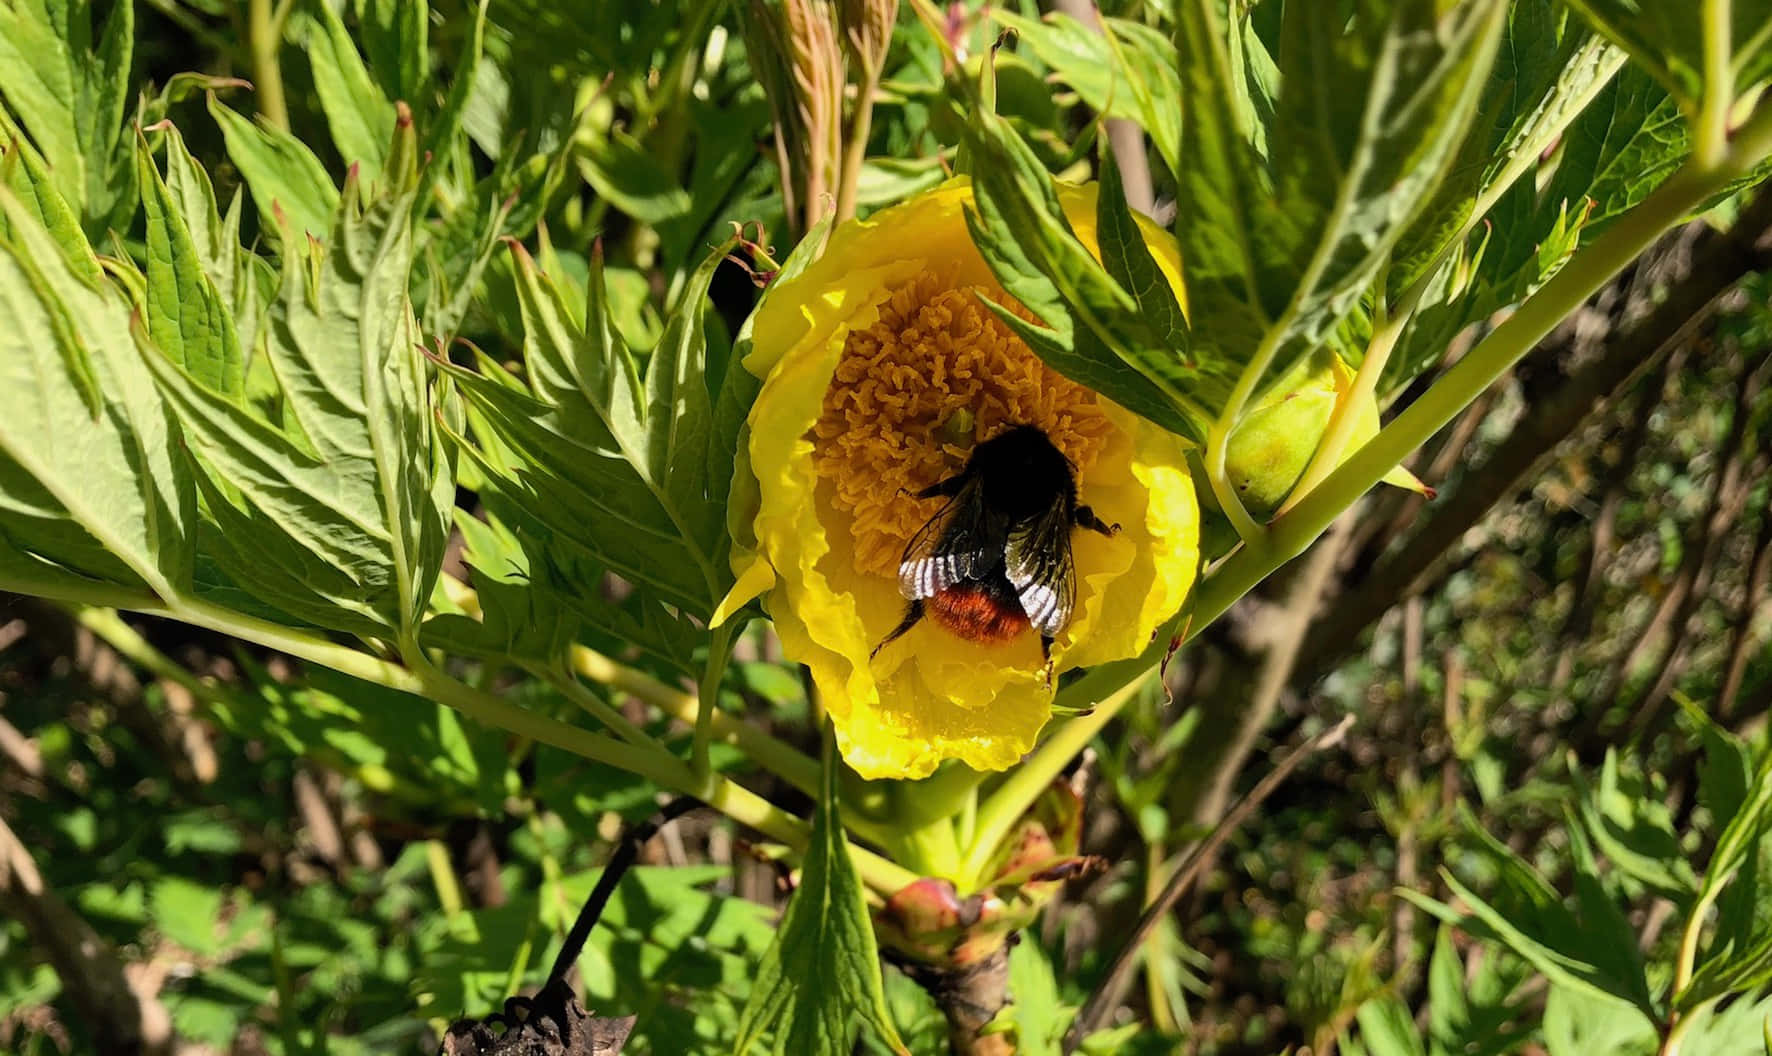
[812,269,1113,576]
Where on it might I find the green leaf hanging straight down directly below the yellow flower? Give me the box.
[732,735,909,1056]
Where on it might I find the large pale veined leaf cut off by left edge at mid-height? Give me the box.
[0,190,195,599]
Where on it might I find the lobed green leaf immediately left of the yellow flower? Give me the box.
[454,235,742,617]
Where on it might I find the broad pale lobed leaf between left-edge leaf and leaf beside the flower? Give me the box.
[144,143,454,645]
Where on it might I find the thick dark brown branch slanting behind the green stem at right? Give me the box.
[1299,188,1772,675]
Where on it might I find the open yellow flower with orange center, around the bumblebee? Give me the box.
[716,179,1200,778]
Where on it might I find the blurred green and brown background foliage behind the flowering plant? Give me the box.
[0,0,1772,1056]
